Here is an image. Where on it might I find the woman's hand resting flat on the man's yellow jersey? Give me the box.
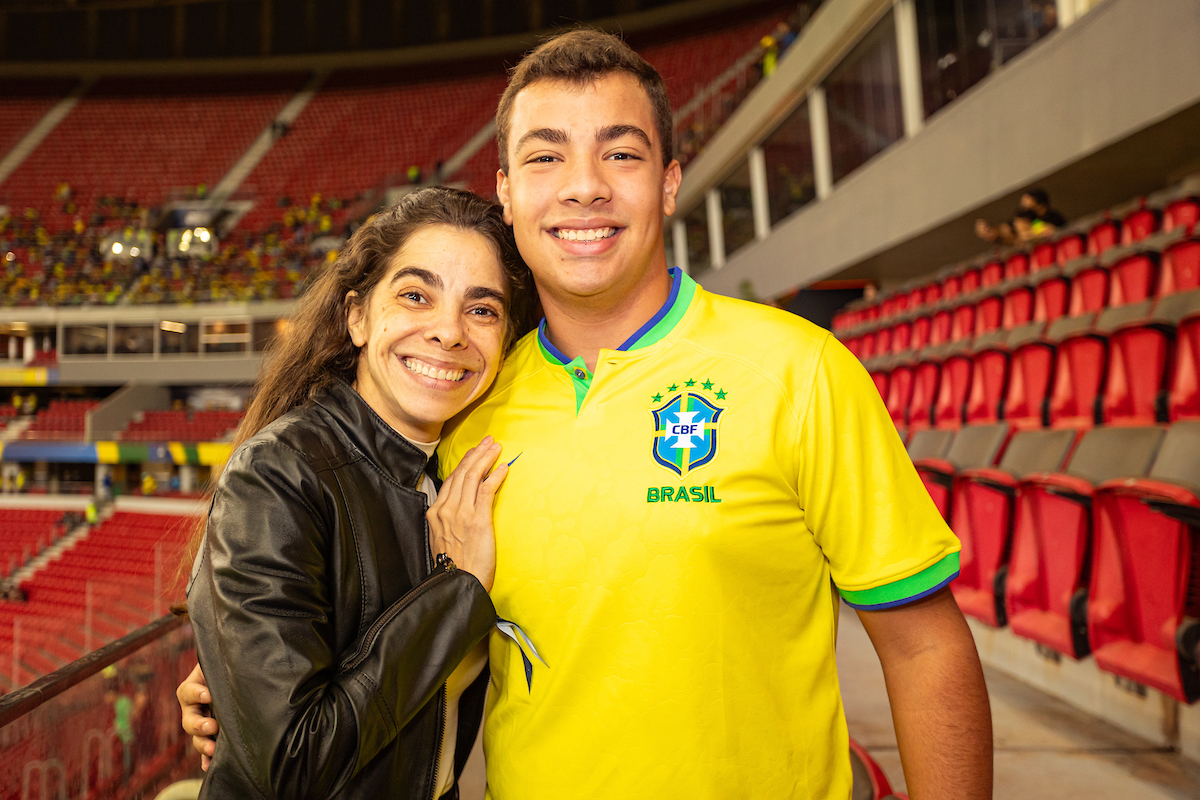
[425,437,509,591]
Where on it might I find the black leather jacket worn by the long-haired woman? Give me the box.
[187,384,497,800]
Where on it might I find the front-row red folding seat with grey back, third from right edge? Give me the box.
[950,429,1076,627]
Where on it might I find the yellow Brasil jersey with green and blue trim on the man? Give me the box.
[442,270,959,800]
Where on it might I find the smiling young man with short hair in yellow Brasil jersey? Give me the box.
[181,30,991,800]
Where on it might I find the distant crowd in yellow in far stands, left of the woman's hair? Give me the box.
[0,193,343,307]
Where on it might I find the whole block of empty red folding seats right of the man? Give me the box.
[834,181,1200,703]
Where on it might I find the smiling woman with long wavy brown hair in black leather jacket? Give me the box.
[180,188,535,798]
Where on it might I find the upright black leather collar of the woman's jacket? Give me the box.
[314,379,427,488]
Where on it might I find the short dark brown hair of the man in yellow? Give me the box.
[496,28,674,174]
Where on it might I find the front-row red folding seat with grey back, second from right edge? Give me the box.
[1006,427,1163,658]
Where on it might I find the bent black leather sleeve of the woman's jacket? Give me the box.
[188,444,496,798]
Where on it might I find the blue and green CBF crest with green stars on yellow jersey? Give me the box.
[650,380,726,479]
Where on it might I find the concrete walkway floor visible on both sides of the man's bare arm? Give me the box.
[838,607,1200,800]
